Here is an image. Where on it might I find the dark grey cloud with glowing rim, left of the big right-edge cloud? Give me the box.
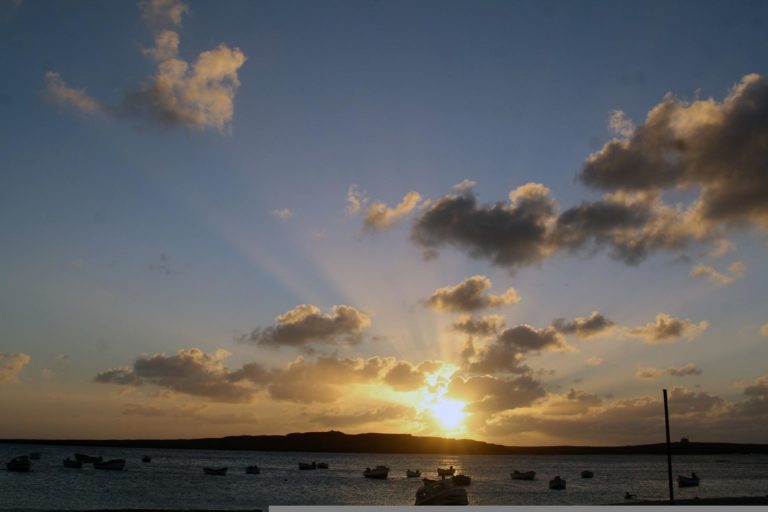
[411,183,557,270]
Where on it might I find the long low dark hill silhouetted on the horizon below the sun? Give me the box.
[0,430,768,455]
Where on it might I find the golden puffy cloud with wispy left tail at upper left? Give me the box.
[46,0,246,131]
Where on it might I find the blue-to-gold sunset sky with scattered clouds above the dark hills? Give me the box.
[0,0,768,445]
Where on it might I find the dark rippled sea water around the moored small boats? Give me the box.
[0,444,768,510]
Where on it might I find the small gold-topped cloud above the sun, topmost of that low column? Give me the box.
[426,275,520,313]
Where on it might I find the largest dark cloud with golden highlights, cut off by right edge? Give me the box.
[580,74,768,227]
